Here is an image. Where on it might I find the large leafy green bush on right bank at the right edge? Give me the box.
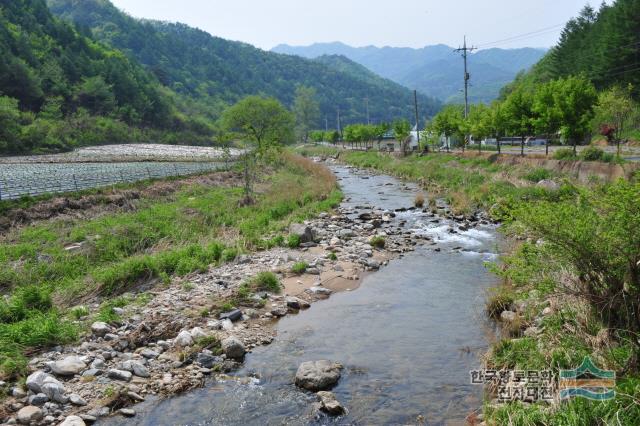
[516,180,640,331]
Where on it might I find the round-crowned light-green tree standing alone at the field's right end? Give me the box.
[221,96,294,204]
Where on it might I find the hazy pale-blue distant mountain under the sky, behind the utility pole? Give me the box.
[272,42,546,102]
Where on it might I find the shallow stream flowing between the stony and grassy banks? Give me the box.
[102,167,497,425]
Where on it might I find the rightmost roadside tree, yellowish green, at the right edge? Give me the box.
[594,86,637,157]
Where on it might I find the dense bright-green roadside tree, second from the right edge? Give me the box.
[553,77,598,154]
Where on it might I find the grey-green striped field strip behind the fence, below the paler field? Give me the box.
[0,162,228,200]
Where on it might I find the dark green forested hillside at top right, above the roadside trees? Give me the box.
[504,0,640,98]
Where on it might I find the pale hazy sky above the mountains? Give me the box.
[107,0,600,49]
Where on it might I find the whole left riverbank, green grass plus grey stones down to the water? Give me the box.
[0,157,440,424]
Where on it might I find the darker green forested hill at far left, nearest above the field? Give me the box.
[0,0,222,154]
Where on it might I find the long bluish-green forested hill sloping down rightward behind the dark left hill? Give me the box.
[49,0,439,126]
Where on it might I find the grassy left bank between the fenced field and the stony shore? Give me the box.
[0,154,341,378]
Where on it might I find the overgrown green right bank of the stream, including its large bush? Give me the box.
[303,148,640,426]
